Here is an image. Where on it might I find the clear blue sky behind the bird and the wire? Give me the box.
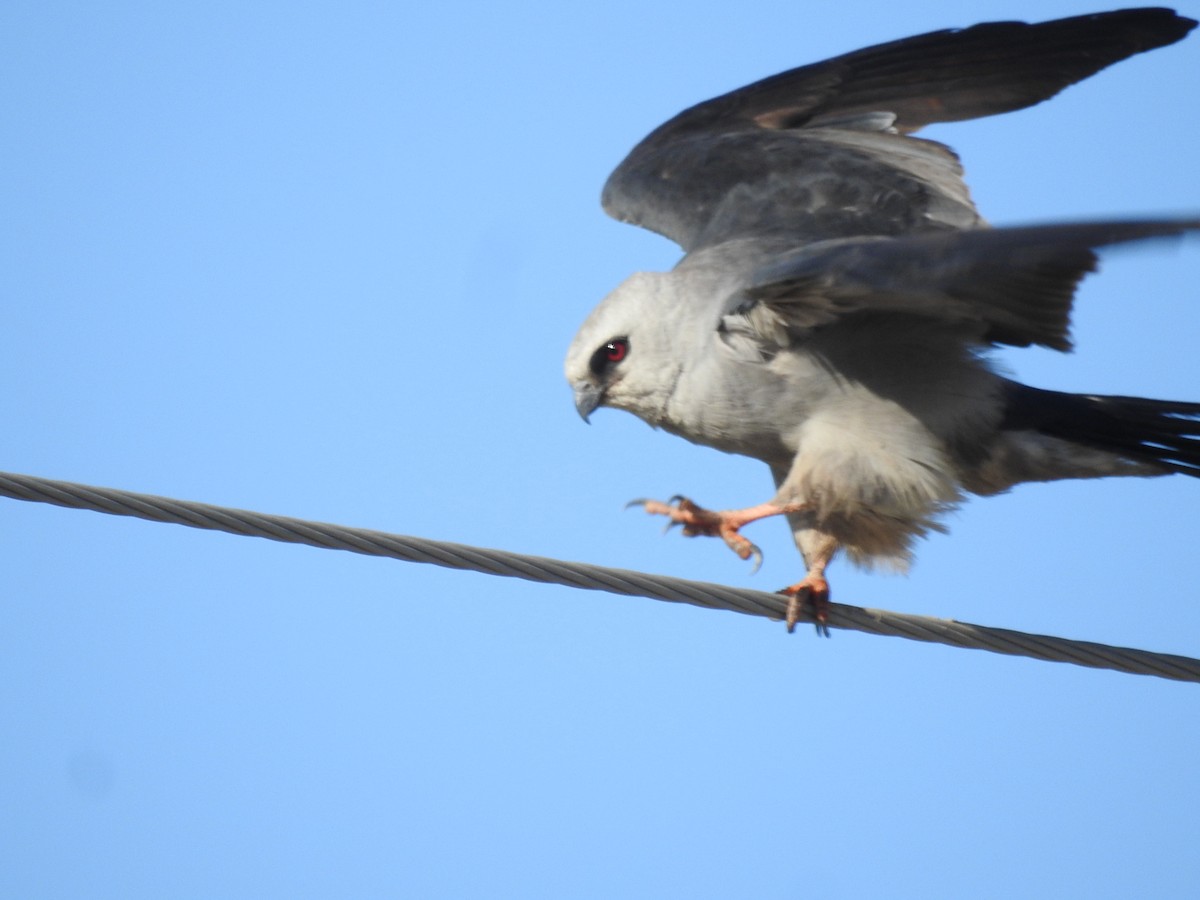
[0,0,1200,898]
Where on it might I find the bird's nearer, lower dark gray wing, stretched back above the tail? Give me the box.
[721,220,1200,350]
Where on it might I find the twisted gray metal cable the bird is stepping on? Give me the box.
[0,473,1200,682]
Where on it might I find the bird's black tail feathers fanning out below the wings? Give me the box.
[1001,382,1200,478]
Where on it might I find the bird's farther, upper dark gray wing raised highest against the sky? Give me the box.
[602,8,1196,251]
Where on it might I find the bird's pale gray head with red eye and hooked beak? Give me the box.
[564,272,680,425]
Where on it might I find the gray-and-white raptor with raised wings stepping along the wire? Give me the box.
[564,8,1200,635]
